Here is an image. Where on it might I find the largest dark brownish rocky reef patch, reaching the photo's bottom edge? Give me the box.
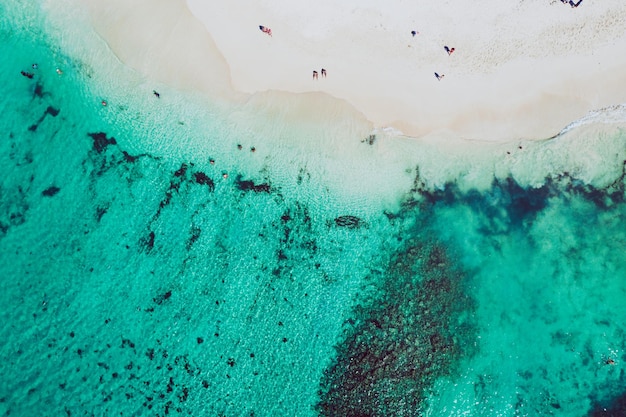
[315,242,475,417]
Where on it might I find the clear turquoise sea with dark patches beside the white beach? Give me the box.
[0,2,626,416]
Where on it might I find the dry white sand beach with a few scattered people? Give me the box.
[79,0,626,140]
